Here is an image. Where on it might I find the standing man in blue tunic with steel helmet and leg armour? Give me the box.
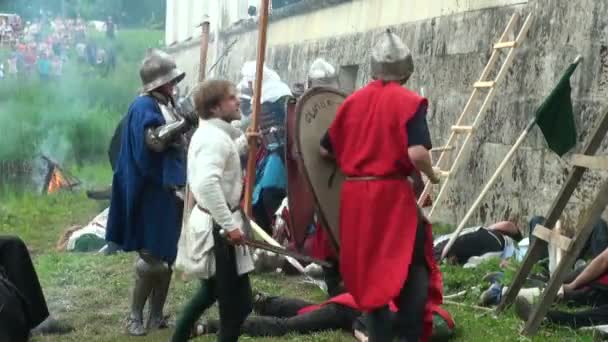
[106,50,196,336]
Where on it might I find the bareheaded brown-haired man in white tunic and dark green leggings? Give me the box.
[172,80,254,341]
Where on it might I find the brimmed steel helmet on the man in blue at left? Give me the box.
[139,49,186,92]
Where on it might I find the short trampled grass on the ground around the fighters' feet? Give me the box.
[0,176,594,342]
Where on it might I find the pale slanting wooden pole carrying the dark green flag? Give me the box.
[440,55,583,261]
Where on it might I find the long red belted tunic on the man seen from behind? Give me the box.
[329,81,436,311]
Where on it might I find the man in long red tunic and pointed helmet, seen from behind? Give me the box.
[321,30,441,342]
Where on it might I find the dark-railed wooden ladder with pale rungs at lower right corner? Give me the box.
[496,110,608,335]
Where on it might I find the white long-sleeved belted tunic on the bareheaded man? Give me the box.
[176,119,254,279]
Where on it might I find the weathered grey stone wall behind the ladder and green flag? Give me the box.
[169,0,608,235]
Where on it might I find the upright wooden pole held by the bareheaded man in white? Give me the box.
[245,0,270,217]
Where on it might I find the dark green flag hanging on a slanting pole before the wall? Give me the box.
[536,63,578,157]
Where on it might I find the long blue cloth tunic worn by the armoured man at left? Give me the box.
[106,96,186,263]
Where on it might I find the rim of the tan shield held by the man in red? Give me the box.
[295,86,348,252]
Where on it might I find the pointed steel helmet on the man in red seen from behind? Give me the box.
[371,29,414,81]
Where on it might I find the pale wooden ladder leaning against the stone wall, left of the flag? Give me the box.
[418,13,532,218]
